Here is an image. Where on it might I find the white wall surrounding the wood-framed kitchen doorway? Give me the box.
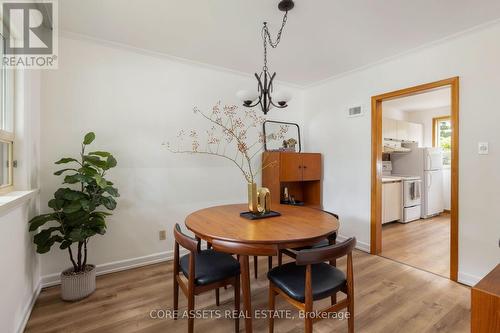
[305,24,500,283]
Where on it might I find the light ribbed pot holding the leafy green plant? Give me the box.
[61,265,95,301]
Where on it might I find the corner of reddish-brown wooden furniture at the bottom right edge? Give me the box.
[471,265,500,333]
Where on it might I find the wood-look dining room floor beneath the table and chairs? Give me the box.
[26,251,470,333]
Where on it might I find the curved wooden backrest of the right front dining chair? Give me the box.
[295,237,356,265]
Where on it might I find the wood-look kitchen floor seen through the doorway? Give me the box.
[381,214,450,278]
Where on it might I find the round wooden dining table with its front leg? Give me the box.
[186,204,339,333]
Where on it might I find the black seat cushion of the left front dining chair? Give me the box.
[180,250,240,285]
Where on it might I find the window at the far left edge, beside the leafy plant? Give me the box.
[0,35,14,192]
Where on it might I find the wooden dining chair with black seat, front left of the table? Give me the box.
[174,224,240,333]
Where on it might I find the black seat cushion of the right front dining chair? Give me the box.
[267,262,346,303]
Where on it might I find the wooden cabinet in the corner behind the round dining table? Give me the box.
[262,152,322,208]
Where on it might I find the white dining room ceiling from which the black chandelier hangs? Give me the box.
[59,0,500,85]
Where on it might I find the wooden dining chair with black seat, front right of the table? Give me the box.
[267,238,356,333]
